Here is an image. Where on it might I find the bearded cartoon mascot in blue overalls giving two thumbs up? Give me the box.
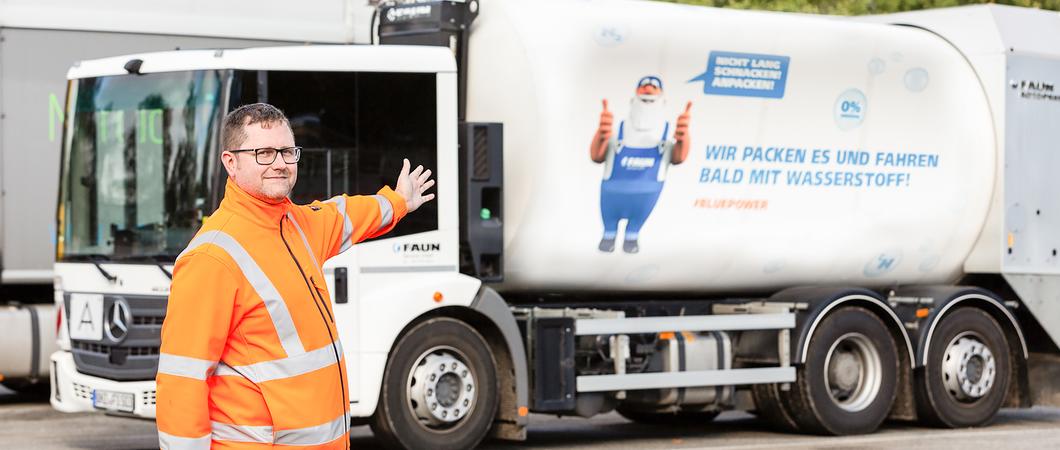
[589,76,692,253]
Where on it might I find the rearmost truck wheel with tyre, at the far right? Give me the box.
[916,308,1011,428]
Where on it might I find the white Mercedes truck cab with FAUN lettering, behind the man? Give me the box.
[52,46,481,417]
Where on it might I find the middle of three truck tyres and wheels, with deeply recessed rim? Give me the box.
[781,307,898,434]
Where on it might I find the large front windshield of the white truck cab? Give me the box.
[56,71,223,260]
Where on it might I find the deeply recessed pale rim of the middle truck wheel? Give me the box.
[825,332,883,412]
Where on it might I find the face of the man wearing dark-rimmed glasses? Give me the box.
[220,123,298,203]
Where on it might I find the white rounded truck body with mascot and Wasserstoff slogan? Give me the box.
[467,0,996,294]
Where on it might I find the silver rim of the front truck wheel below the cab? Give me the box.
[405,346,477,430]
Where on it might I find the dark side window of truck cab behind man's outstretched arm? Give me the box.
[267,72,443,237]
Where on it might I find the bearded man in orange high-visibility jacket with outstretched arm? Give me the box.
[156,104,435,449]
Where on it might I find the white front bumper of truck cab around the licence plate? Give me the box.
[51,350,155,419]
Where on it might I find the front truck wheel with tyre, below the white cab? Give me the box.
[371,318,497,449]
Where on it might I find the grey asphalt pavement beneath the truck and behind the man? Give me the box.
[0,388,1060,450]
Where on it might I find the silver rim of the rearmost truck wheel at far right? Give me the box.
[942,331,997,403]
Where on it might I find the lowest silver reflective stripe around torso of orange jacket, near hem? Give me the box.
[208,413,349,446]
